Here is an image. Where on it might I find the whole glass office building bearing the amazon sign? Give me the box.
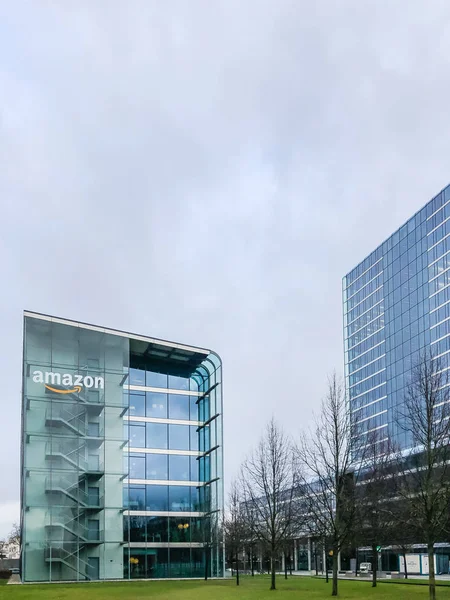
[21,312,224,582]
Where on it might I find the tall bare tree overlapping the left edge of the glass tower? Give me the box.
[297,374,361,596]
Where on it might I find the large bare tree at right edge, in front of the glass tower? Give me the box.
[397,351,450,600]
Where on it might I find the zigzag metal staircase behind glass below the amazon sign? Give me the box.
[43,382,105,580]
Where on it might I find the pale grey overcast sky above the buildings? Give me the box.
[0,0,450,536]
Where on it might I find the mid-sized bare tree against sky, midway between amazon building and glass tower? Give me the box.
[241,419,296,590]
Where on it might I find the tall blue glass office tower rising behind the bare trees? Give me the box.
[343,186,450,449]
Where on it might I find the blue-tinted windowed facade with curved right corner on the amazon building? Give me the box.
[124,354,223,579]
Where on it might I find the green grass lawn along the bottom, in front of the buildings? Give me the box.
[0,576,450,600]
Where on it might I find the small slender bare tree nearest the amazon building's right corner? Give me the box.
[224,481,249,585]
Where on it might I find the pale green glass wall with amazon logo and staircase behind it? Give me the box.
[21,316,129,581]
